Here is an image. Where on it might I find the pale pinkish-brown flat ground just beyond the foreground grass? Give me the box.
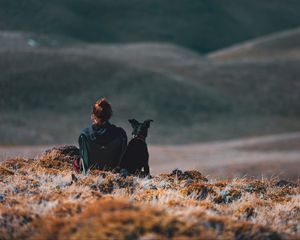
[0,132,300,180]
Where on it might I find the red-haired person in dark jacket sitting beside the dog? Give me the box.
[75,98,127,174]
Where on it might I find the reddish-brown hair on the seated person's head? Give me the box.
[91,98,112,124]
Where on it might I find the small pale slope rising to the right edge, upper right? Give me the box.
[209,28,300,61]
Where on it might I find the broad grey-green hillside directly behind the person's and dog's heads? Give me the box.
[0,31,300,144]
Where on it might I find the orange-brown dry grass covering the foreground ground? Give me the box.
[0,150,300,239]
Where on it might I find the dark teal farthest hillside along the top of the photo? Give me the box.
[0,0,300,52]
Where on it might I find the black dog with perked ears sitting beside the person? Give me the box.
[120,119,153,176]
